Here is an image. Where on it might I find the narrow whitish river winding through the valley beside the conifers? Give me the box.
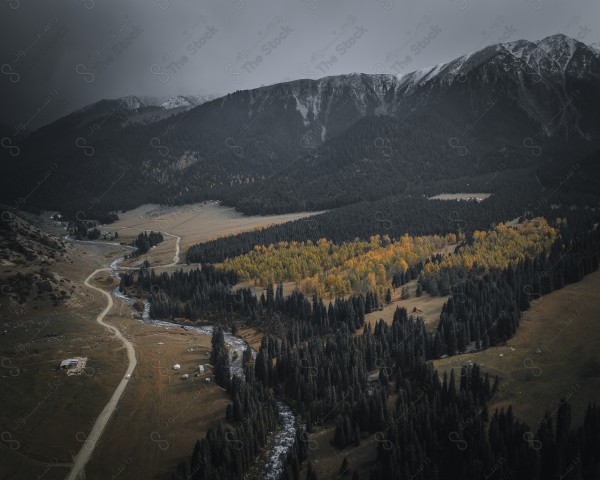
[110,257,298,480]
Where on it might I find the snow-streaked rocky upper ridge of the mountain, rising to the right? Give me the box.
[230,34,598,142]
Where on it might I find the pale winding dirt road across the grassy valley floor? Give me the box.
[66,232,181,480]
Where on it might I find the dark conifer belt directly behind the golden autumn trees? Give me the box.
[186,178,600,264]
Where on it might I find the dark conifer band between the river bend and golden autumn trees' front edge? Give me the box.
[120,265,392,342]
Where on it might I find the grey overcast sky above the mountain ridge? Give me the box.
[0,0,600,130]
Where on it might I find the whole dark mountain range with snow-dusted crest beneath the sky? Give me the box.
[0,34,600,217]
